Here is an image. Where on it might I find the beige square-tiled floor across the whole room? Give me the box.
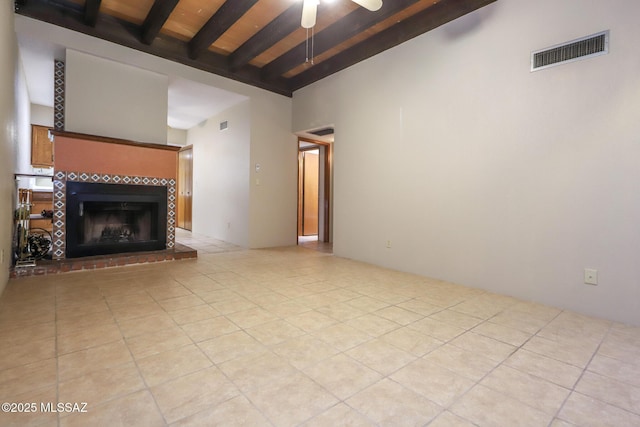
[0,235,640,427]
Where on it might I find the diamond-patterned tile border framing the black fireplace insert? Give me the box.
[52,171,177,260]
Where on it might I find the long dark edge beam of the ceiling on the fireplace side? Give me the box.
[17,0,291,97]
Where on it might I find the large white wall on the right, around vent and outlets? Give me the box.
[293,0,640,324]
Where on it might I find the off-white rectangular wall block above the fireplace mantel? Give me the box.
[65,49,169,144]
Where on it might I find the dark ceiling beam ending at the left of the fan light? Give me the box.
[229,2,302,70]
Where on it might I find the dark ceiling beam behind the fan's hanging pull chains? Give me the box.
[262,0,418,80]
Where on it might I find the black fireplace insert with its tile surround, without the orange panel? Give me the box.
[53,170,176,259]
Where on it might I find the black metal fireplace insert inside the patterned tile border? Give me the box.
[65,182,167,258]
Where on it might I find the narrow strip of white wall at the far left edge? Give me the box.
[0,2,23,293]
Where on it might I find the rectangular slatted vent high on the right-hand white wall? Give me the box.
[531,30,609,71]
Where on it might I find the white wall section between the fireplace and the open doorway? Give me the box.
[187,94,297,248]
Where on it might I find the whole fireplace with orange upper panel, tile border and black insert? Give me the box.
[52,132,179,260]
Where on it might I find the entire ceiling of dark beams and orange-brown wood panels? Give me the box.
[15,0,495,96]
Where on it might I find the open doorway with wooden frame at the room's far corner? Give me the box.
[297,138,332,252]
